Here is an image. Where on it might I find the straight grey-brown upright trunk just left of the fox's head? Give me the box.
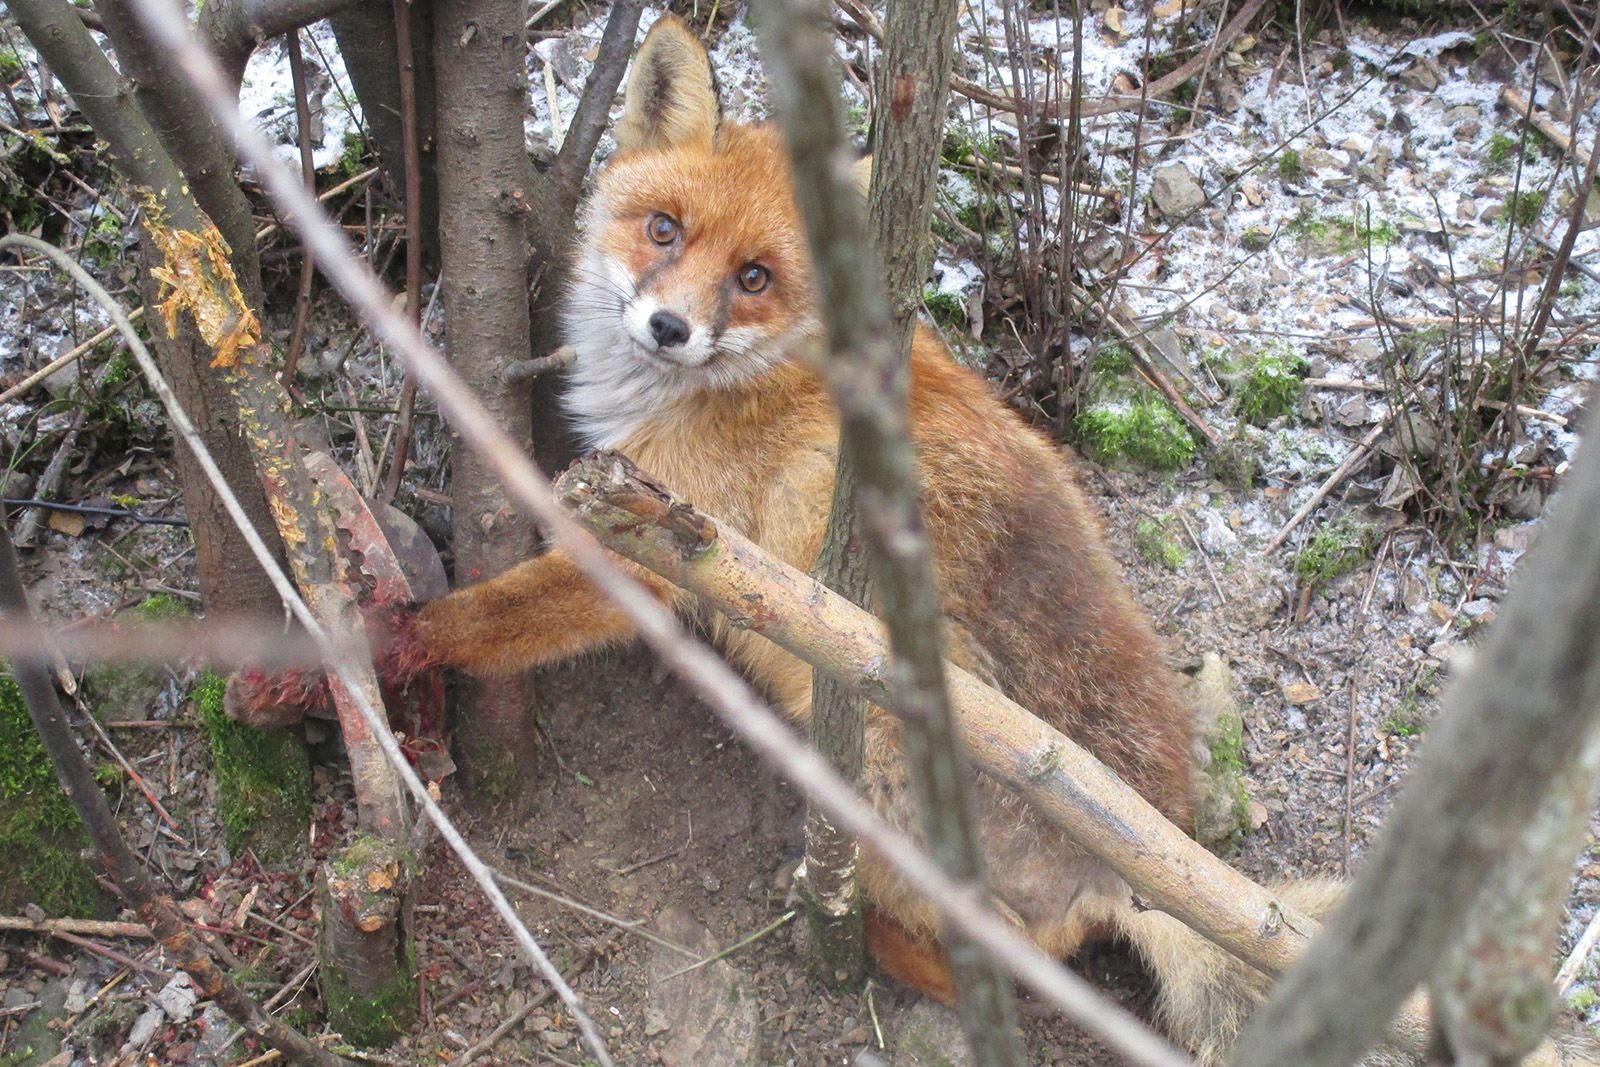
[434,0,538,797]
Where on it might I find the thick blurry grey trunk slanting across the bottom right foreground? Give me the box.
[1235,403,1600,1067]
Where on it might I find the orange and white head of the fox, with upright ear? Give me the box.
[566,16,821,446]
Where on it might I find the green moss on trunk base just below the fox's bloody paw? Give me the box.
[194,672,310,862]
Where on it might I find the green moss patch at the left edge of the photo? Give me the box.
[0,675,104,918]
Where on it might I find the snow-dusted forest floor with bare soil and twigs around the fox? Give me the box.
[0,3,1600,1067]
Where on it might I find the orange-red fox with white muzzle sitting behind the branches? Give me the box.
[393,16,1305,1059]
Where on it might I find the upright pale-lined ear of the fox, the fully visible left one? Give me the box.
[616,14,722,155]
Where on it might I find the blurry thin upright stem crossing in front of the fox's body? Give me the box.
[758,0,1022,1065]
